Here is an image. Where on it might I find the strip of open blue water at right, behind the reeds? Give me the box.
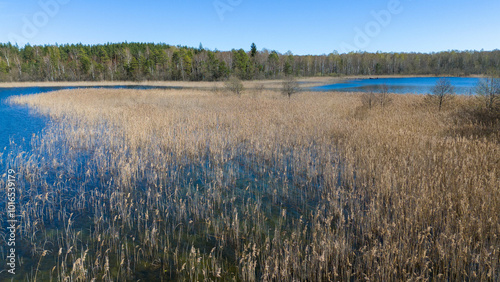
[312,77,480,95]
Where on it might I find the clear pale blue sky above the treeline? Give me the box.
[0,0,500,55]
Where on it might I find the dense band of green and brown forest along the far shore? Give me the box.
[0,43,500,81]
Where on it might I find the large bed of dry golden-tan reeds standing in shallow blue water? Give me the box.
[1,89,500,281]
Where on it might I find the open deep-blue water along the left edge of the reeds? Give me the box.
[0,85,182,281]
